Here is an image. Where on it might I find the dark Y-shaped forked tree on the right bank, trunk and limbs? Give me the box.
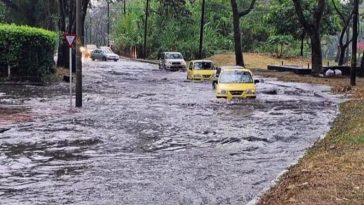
[292,0,326,75]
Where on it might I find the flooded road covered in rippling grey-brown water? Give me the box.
[0,58,339,205]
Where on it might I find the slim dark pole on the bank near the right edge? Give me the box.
[350,0,359,86]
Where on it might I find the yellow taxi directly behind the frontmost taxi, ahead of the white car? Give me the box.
[187,60,216,80]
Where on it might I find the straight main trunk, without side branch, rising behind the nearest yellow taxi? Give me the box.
[231,0,245,66]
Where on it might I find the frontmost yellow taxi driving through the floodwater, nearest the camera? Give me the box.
[216,66,259,99]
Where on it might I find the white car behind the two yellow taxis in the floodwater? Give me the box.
[159,52,187,71]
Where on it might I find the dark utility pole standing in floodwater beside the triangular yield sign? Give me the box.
[76,0,83,107]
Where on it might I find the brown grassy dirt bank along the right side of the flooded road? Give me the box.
[211,54,364,205]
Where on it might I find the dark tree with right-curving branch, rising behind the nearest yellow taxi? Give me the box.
[231,0,256,66]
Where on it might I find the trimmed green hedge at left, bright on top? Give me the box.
[0,24,58,81]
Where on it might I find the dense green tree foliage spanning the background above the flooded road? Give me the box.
[0,0,358,73]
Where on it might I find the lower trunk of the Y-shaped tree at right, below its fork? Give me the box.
[310,31,322,76]
